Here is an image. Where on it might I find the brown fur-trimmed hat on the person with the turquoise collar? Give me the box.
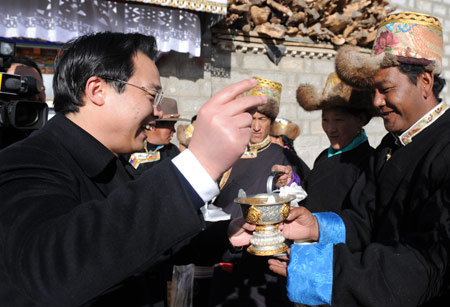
[297,72,376,124]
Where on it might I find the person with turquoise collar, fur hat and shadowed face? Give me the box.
[297,73,375,212]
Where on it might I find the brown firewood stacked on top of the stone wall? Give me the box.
[224,0,394,47]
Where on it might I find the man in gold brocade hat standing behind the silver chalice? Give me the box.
[210,78,309,306]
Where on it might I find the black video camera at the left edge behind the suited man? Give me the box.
[0,40,48,130]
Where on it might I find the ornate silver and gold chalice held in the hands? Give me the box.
[234,193,295,256]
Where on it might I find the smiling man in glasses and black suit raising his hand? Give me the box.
[0,32,265,306]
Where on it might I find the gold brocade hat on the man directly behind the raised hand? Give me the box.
[244,77,282,119]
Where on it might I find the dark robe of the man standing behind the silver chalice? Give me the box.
[210,143,309,307]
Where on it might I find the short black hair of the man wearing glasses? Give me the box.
[53,32,157,114]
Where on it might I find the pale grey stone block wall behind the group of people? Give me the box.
[158,0,450,167]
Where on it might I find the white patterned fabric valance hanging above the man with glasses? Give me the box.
[0,0,201,56]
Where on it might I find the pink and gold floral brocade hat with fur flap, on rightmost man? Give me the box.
[336,12,444,88]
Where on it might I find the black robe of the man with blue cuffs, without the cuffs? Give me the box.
[332,111,450,306]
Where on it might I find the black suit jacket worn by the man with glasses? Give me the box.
[0,114,204,306]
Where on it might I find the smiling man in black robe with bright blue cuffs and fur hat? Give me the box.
[258,12,450,306]
